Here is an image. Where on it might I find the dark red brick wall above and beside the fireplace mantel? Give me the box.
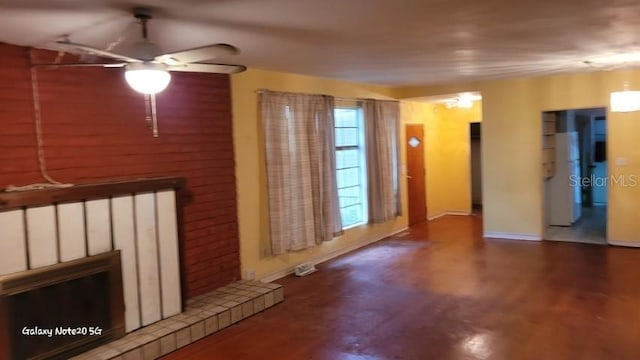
[0,43,240,297]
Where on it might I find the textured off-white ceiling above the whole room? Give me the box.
[0,0,640,85]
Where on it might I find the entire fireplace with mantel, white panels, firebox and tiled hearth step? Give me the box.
[0,178,284,360]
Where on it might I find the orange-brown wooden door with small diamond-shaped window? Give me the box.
[405,124,427,225]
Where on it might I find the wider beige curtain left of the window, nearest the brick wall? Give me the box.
[260,91,342,255]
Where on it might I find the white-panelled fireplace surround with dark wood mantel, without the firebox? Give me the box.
[0,178,184,358]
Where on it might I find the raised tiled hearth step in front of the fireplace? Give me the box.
[72,280,284,360]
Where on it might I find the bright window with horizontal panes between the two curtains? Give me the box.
[334,107,368,229]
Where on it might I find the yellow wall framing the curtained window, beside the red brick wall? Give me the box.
[231,69,407,278]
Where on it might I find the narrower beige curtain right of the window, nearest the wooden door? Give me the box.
[363,100,402,223]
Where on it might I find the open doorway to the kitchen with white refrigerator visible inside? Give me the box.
[543,108,609,244]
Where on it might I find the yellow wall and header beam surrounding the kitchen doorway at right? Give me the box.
[393,70,640,244]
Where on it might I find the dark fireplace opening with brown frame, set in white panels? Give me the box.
[0,251,125,359]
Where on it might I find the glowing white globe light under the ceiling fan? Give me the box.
[124,63,171,95]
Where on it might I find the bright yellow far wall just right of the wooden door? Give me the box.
[402,101,482,218]
